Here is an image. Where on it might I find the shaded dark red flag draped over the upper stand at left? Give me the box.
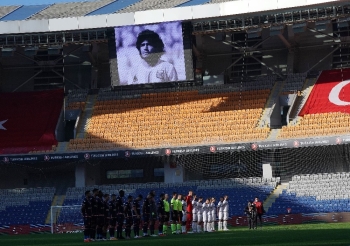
[0,90,64,154]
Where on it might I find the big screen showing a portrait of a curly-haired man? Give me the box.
[115,22,186,85]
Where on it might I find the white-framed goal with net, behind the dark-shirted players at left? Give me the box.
[50,205,84,233]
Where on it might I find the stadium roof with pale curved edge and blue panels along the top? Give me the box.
[0,0,349,34]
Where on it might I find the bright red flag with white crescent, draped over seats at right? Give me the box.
[299,69,350,116]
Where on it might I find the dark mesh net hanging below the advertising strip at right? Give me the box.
[176,144,350,181]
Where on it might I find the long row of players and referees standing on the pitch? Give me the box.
[81,189,229,242]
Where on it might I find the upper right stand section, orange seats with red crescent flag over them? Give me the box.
[278,69,350,139]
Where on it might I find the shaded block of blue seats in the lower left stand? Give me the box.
[0,187,55,225]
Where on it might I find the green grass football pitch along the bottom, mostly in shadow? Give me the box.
[0,223,350,246]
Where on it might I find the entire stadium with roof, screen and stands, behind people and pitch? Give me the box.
[0,0,350,245]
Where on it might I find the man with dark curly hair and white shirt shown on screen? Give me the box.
[128,30,178,84]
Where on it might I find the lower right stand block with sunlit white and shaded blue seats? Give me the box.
[268,172,350,214]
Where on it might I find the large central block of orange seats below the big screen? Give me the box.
[68,83,270,151]
